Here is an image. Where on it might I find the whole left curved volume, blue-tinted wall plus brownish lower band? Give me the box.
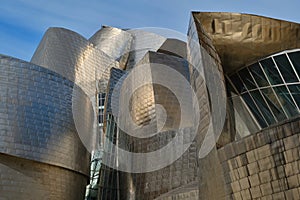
[0,56,89,199]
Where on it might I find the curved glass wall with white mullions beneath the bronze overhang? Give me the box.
[229,49,300,128]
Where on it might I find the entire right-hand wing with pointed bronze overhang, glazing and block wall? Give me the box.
[188,12,300,199]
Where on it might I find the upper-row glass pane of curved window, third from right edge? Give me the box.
[260,58,283,85]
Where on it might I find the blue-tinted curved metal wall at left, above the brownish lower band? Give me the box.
[0,56,91,174]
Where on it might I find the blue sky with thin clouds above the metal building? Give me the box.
[0,0,300,61]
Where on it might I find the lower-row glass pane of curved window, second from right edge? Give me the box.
[274,86,298,117]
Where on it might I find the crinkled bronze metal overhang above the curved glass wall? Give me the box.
[192,12,300,74]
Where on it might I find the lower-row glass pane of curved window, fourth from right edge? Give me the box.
[250,90,276,124]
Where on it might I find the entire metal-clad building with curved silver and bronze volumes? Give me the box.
[0,12,300,200]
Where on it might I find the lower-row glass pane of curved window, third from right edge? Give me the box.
[261,88,286,121]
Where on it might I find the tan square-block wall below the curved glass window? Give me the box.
[218,118,300,200]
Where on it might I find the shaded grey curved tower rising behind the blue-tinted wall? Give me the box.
[30,28,89,81]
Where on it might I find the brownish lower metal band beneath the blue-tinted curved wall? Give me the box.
[0,153,87,200]
